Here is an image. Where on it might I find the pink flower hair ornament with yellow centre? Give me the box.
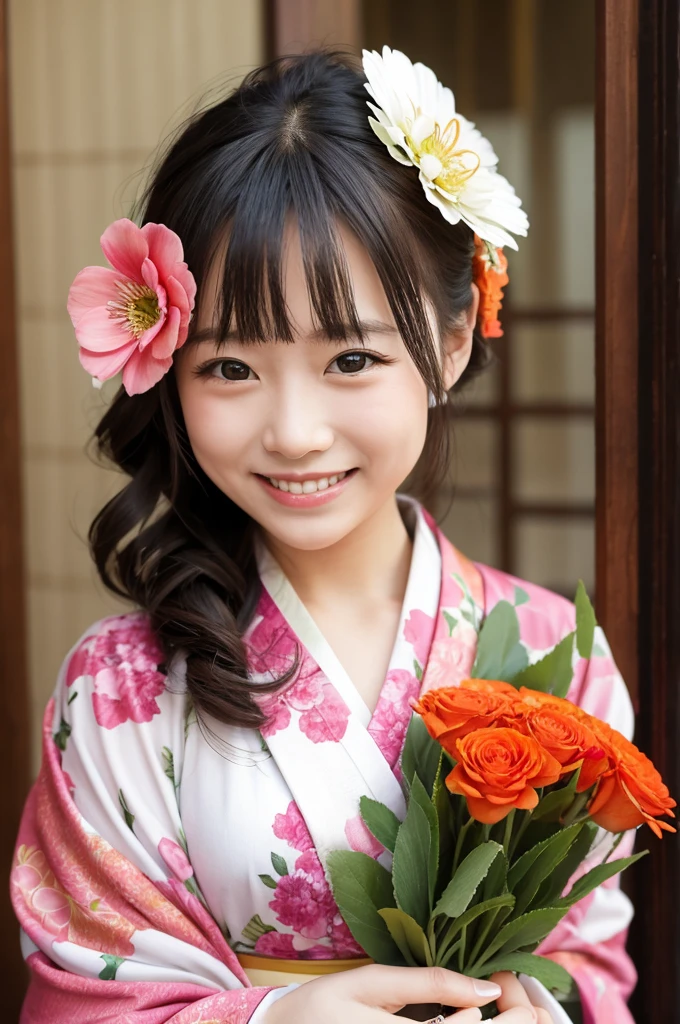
[67,217,196,395]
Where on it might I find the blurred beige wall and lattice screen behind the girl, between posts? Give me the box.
[9,0,595,768]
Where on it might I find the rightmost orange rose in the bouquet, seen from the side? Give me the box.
[588,722,676,839]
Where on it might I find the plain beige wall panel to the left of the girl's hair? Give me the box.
[9,0,263,766]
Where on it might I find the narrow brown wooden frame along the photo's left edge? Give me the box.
[0,0,30,1007]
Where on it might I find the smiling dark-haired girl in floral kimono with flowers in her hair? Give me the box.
[11,48,635,1024]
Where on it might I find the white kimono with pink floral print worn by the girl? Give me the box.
[11,496,635,1024]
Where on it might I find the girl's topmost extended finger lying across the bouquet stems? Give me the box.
[346,964,501,1010]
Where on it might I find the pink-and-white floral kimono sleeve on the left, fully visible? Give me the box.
[10,612,285,1024]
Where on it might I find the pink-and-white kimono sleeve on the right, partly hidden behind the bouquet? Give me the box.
[537,627,637,1024]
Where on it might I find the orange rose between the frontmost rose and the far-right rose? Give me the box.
[525,700,609,793]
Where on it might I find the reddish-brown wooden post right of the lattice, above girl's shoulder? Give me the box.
[595,0,638,696]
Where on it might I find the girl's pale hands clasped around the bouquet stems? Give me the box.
[264,964,551,1024]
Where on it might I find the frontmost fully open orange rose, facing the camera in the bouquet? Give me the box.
[447,728,562,825]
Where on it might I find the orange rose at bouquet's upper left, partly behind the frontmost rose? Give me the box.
[414,680,516,756]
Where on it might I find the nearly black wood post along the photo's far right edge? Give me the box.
[631,0,680,1024]
